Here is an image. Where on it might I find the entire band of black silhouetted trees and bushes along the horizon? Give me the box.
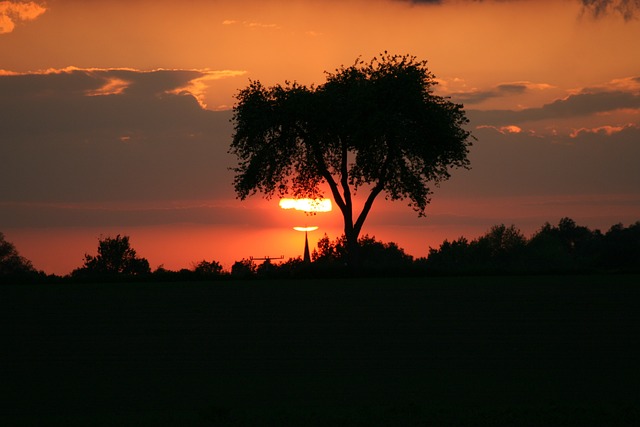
[0,218,640,283]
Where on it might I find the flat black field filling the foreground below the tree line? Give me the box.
[0,276,640,426]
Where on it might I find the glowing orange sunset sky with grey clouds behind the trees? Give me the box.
[0,0,640,274]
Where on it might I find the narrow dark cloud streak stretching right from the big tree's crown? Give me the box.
[469,90,640,126]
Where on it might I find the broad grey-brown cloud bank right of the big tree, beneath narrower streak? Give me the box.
[439,126,640,197]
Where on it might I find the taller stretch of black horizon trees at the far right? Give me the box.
[418,218,640,274]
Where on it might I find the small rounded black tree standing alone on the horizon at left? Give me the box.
[72,234,151,276]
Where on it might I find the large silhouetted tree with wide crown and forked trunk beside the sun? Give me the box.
[230,52,471,266]
